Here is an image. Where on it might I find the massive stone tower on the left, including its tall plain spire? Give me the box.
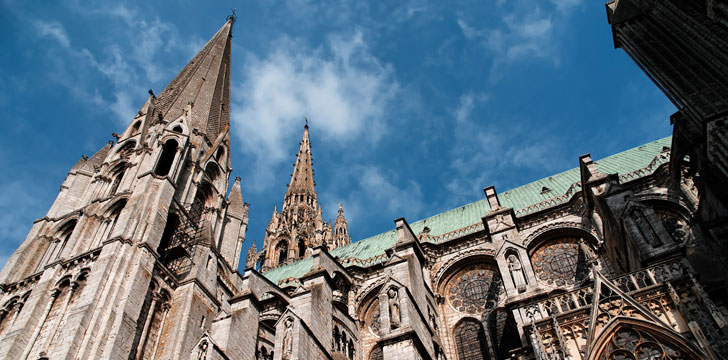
[0,17,248,359]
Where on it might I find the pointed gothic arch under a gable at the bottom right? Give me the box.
[585,316,706,360]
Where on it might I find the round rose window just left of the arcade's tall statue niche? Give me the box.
[447,264,503,314]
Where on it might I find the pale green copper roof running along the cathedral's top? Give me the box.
[264,136,672,286]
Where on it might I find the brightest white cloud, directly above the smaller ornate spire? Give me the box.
[232,33,399,190]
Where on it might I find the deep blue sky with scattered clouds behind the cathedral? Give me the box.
[0,0,675,270]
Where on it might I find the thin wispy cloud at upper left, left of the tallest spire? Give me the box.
[31,4,193,125]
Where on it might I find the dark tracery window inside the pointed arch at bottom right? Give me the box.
[597,327,696,360]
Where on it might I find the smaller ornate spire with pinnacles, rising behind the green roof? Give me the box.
[255,124,351,270]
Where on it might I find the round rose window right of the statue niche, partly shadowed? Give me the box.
[531,238,587,286]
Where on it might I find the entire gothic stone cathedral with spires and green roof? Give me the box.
[0,0,728,360]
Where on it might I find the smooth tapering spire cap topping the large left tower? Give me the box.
[156,16,235,141]
